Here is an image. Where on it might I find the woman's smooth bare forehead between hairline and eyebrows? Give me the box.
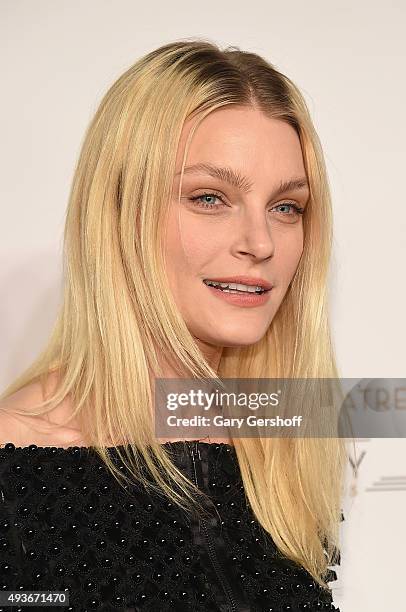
[176,106,305,183]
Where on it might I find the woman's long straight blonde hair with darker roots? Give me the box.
[1,39,347,589]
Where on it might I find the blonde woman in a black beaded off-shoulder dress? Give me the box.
[0,40,346,612]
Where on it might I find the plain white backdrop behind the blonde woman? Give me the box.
[0,0,406,612]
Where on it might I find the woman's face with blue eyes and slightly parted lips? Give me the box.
[165,107,309,360]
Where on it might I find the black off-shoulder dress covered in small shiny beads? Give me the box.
[0,441,338,612]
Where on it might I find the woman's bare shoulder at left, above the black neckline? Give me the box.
[0,378,87,446]
